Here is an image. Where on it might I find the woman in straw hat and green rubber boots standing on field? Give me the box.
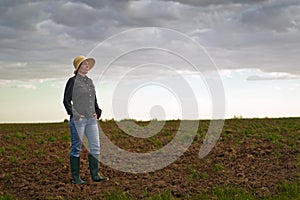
[63,56,108,184]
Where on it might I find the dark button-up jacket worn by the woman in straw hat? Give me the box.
[63,74,102,120]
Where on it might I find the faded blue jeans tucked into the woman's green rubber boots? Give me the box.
[69,117,100,157]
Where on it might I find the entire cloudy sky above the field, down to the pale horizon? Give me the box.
[0,0,300,122]
